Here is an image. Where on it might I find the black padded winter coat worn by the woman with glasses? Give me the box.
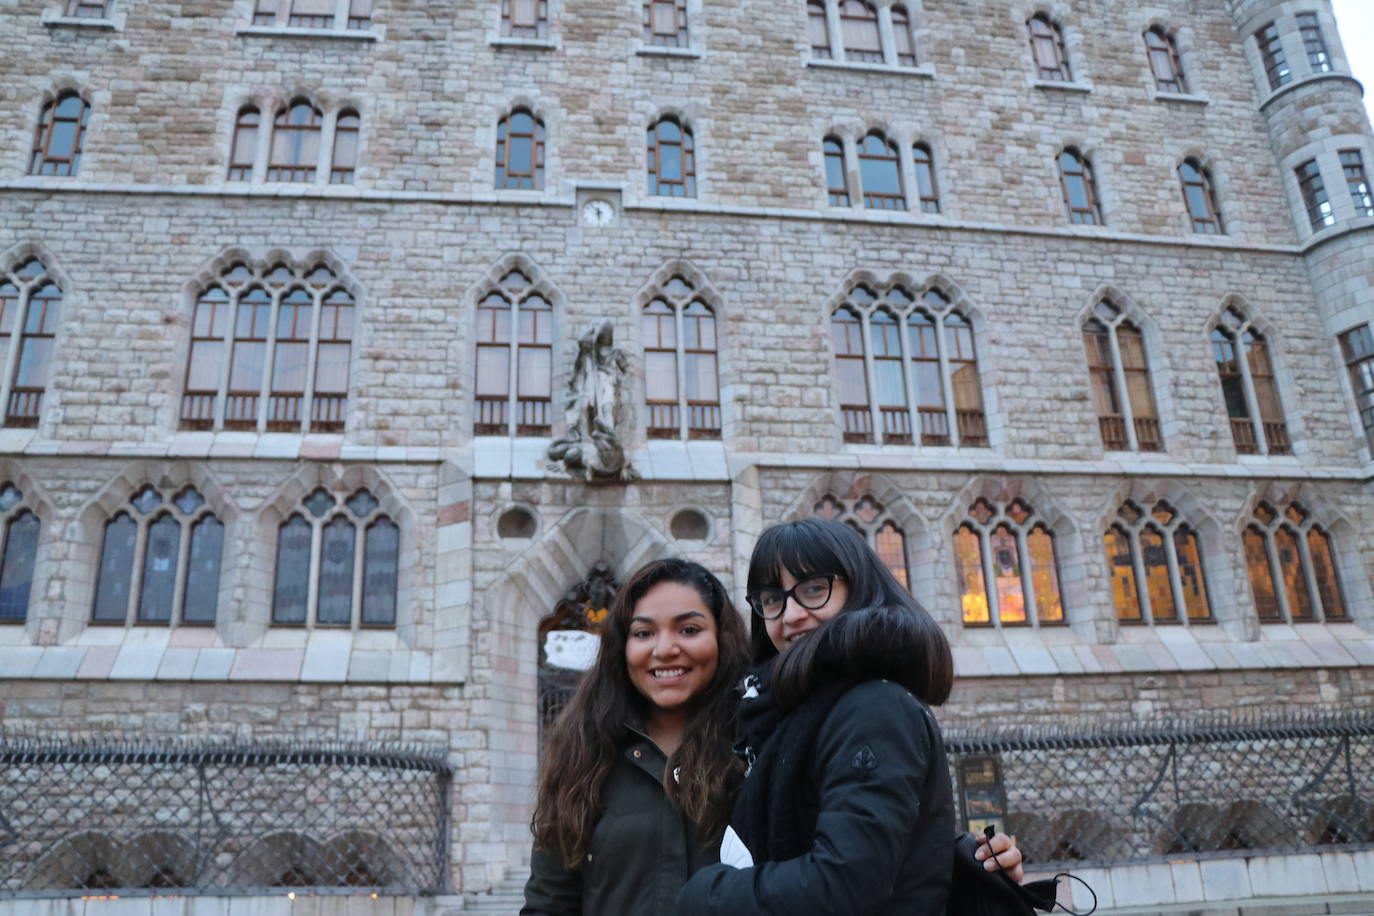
[677,681,954,916]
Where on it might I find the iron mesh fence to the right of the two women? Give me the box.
[947,711,1374,865]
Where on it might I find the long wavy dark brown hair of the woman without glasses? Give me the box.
[530,559,747,868]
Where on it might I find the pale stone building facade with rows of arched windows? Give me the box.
[0,0,1374,906]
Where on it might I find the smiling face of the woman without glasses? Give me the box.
[625,582,719,717]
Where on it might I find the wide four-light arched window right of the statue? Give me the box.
[831,284,988,446]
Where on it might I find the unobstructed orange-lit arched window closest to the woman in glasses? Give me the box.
[954,497,1066,626]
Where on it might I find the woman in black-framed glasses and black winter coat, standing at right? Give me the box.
[677,519,1021,916]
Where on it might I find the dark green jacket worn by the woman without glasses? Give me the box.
[521,729,720,916]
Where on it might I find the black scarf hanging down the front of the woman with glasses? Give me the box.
[730,669,855,862]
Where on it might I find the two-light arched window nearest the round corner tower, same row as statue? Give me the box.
[1212,308,1292,455]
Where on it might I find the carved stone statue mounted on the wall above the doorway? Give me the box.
[548,321,638,481]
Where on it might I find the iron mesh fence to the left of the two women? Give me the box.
[0,735,452,897]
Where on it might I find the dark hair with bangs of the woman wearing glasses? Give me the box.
[746,519,954,706]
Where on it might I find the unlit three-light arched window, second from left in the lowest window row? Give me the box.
[91,485,224,625]
